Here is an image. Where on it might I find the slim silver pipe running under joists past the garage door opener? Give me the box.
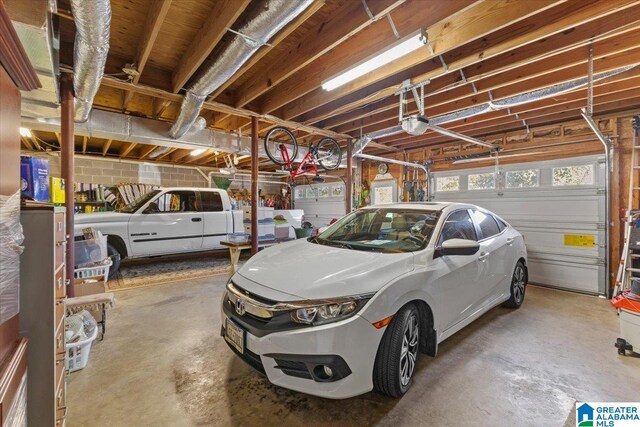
[360,64,640,149]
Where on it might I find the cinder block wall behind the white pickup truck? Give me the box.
[39,153,279,193]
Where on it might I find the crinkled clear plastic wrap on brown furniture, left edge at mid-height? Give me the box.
[0,191,24,324]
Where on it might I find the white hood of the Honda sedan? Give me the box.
[238,239,414,300]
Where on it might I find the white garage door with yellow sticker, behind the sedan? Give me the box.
[431,156,605,294]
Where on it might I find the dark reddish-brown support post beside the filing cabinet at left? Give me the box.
[60,73,75,297]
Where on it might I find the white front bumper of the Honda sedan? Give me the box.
[222,310,385,399]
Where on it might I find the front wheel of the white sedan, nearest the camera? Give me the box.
[373,304,420,398]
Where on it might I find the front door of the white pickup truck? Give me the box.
[129,190,204,256]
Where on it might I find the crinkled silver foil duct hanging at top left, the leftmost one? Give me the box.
[71,0,111,123]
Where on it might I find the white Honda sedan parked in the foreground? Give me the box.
[222,203,527,399]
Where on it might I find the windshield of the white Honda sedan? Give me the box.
[309,208,440,253]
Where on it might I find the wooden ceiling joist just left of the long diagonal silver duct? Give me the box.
[171,0,250,93]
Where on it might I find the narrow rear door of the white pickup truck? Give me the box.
[200,190,233,249]
